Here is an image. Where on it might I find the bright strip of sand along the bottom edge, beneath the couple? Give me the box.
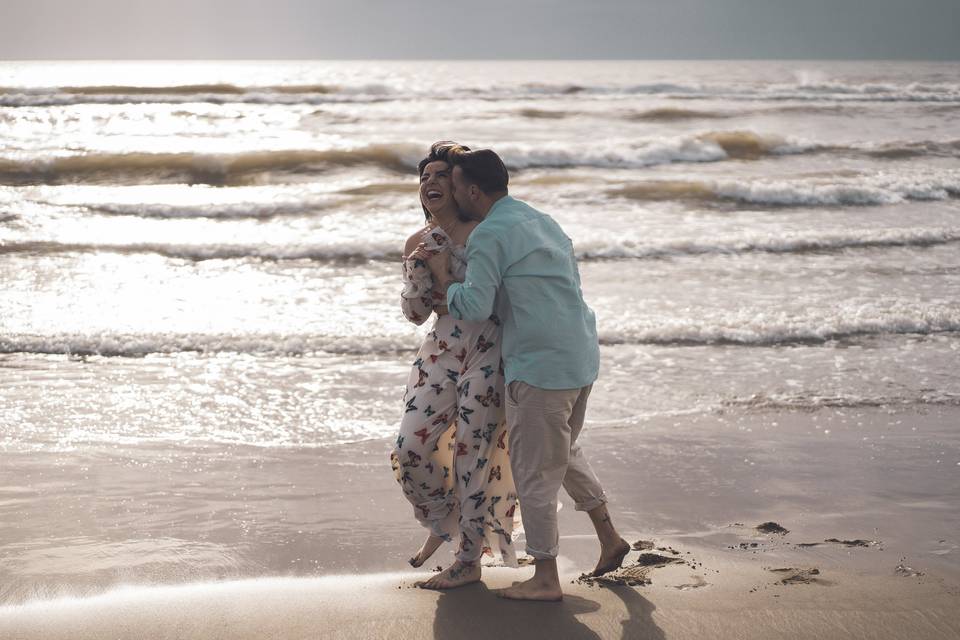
[0,563,960,640]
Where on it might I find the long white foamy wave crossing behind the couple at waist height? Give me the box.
[0,302,960,357]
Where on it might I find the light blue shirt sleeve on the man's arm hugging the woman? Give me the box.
[447,227,507,322]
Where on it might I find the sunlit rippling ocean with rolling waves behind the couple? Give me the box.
[0,61,960,603]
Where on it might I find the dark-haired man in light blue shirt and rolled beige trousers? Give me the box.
[429,149,630,600]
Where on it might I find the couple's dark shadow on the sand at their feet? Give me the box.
[433,582,664,640]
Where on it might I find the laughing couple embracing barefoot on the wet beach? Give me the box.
[391,142,630,600]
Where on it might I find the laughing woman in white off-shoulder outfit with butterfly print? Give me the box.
[390,142,516,589]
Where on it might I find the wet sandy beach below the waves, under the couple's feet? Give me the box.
[0,406,960,640]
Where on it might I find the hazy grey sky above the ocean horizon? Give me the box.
[0,0,960,60]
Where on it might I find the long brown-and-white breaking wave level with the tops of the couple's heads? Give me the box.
[0,131,960,185]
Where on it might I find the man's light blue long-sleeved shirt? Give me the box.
[447,196,600,389]
